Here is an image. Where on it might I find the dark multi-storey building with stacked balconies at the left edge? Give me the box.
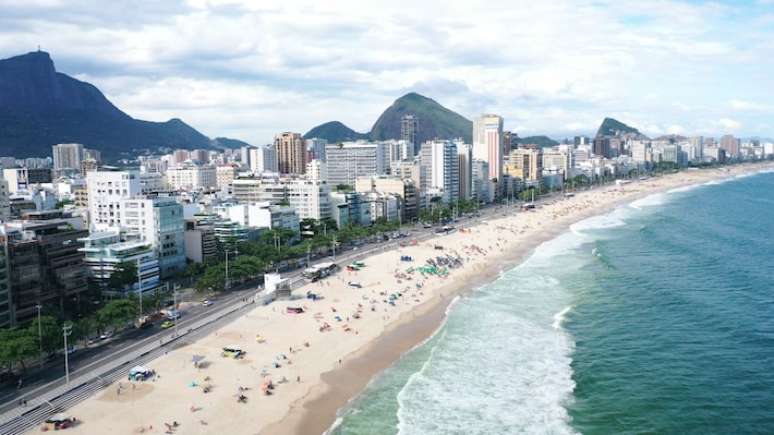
[0,219,88,326]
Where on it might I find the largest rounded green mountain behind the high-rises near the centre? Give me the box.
[369,92,473,143]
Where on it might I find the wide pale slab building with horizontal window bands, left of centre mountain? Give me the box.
[325,142,387,186]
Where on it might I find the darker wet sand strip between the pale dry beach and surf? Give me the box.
[260,163,774,435]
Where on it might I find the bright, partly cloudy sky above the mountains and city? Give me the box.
[0,0,774,144]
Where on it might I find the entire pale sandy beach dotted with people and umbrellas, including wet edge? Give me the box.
[53,163,774,434]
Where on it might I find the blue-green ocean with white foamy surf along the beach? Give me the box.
[330,173,774,435]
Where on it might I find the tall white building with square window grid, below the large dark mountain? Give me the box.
[86,171,142,231]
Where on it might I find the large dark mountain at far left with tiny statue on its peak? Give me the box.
[0,51,210,159]
